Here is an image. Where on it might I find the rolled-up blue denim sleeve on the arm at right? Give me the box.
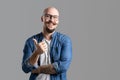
[53,37,72,73]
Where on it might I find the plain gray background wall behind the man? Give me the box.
[0,0,120,80]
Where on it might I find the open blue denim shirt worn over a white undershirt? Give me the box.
[22,32,72,80]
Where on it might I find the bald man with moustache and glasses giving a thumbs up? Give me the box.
[22,7,72,80]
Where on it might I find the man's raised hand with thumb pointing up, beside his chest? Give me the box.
[33,39,47,54]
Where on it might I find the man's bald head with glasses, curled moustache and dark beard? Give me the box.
[41,7,59,33]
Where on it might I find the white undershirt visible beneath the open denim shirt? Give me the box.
[36,38,51,80]
